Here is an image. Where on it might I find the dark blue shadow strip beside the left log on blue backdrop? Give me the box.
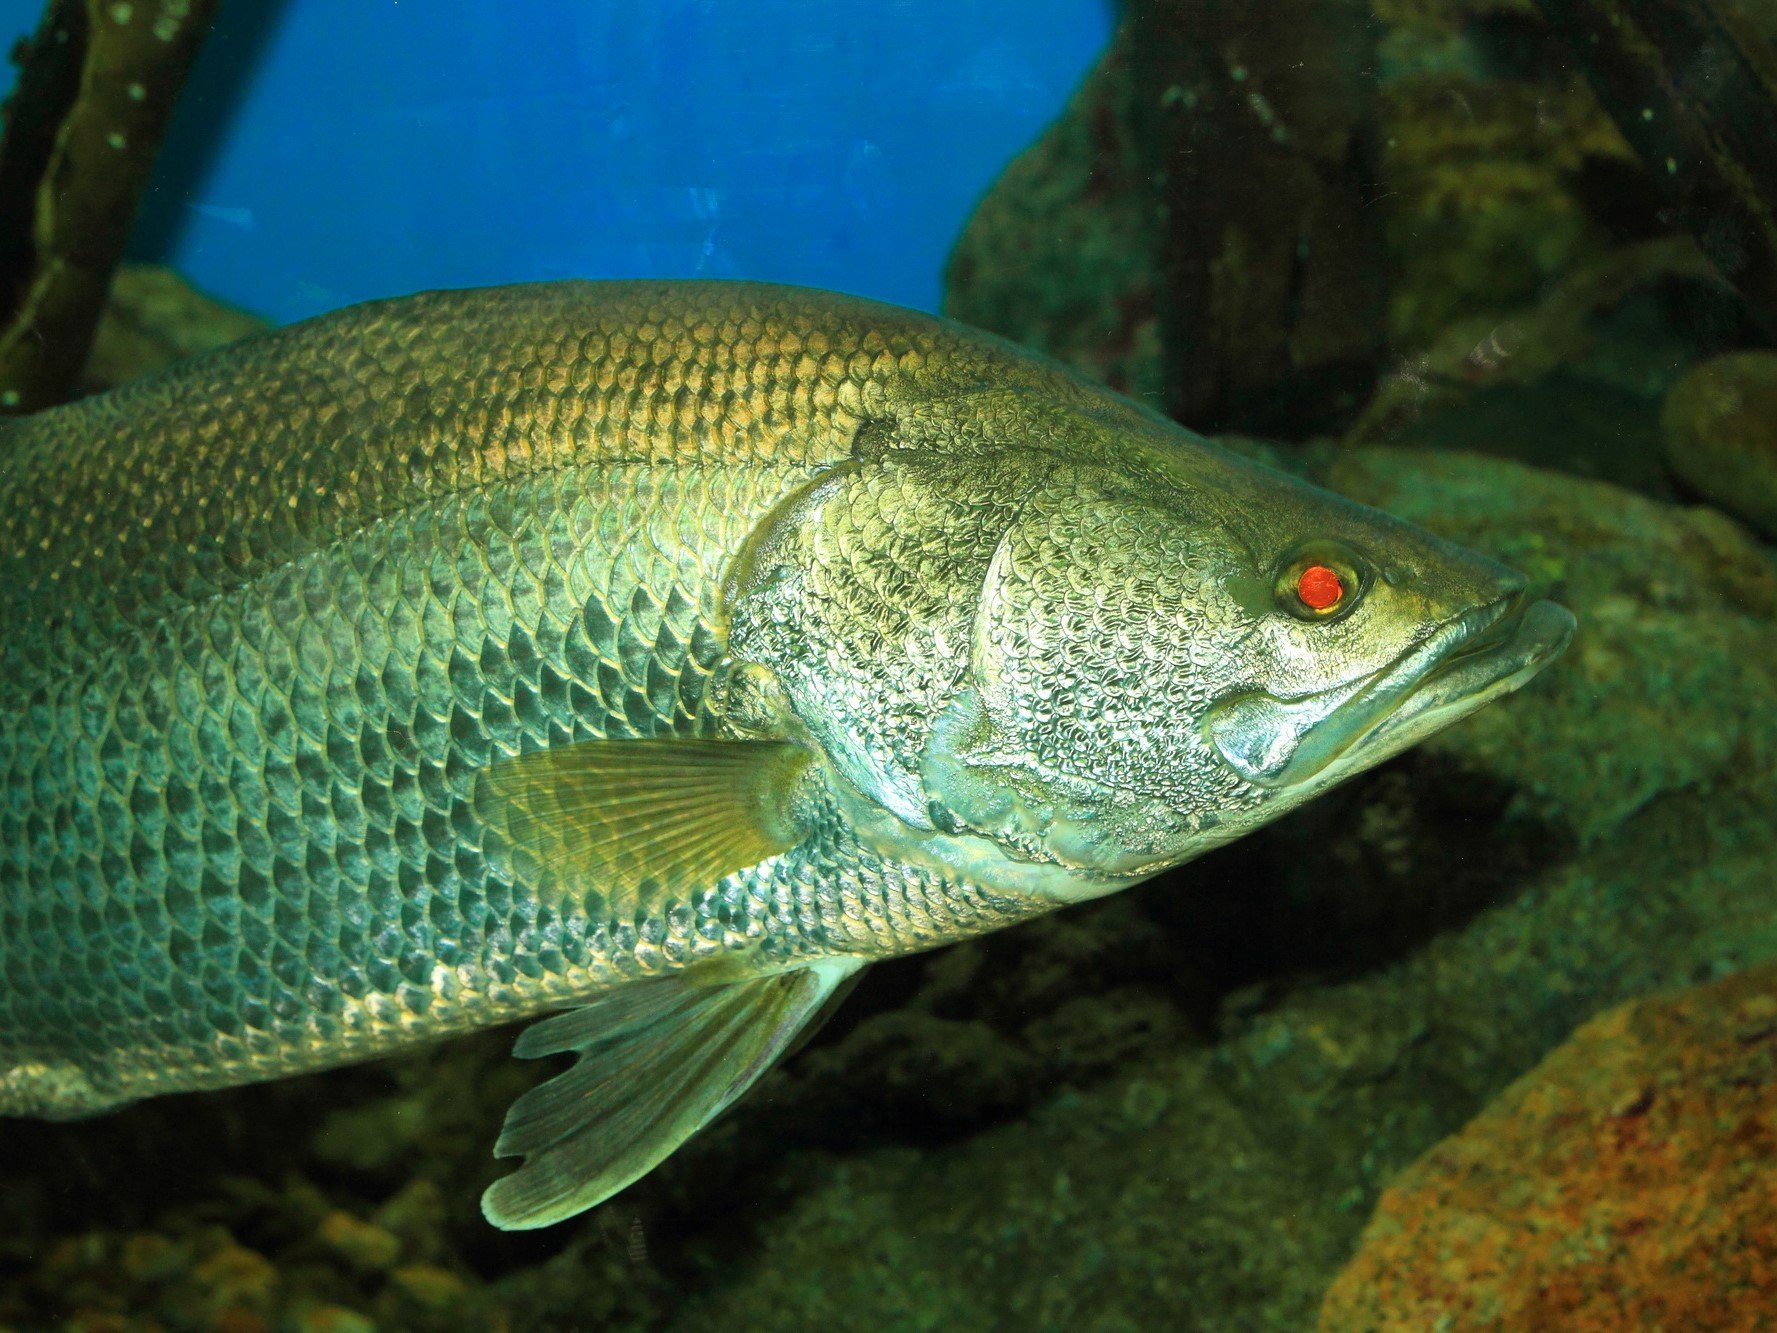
[130,0,290,261]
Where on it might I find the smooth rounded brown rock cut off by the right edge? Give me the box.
[1660,352,1777,540]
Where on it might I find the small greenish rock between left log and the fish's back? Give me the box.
[78,263,272,393]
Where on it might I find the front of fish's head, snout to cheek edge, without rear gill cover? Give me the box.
[922,441,1573,898]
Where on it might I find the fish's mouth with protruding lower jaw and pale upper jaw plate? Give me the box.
[1205,588,1574,789]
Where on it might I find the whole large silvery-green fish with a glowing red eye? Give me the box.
[0,283,1573,1228]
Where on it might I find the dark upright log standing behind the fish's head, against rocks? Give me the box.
[1127,0,1383,432]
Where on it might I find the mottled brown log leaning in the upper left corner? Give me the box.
[0,0,220,412]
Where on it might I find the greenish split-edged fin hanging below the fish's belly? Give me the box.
[482,958,862,1230]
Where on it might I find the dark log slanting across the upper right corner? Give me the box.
[1539,0,1777,332]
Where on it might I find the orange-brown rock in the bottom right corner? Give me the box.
[1320,967,1777,1333]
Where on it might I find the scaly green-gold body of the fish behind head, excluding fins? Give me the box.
[0,284,1037,1114]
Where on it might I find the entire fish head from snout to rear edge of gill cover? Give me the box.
[730,412,1573,901]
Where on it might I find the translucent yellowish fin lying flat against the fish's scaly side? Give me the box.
[476,739,809,921]
